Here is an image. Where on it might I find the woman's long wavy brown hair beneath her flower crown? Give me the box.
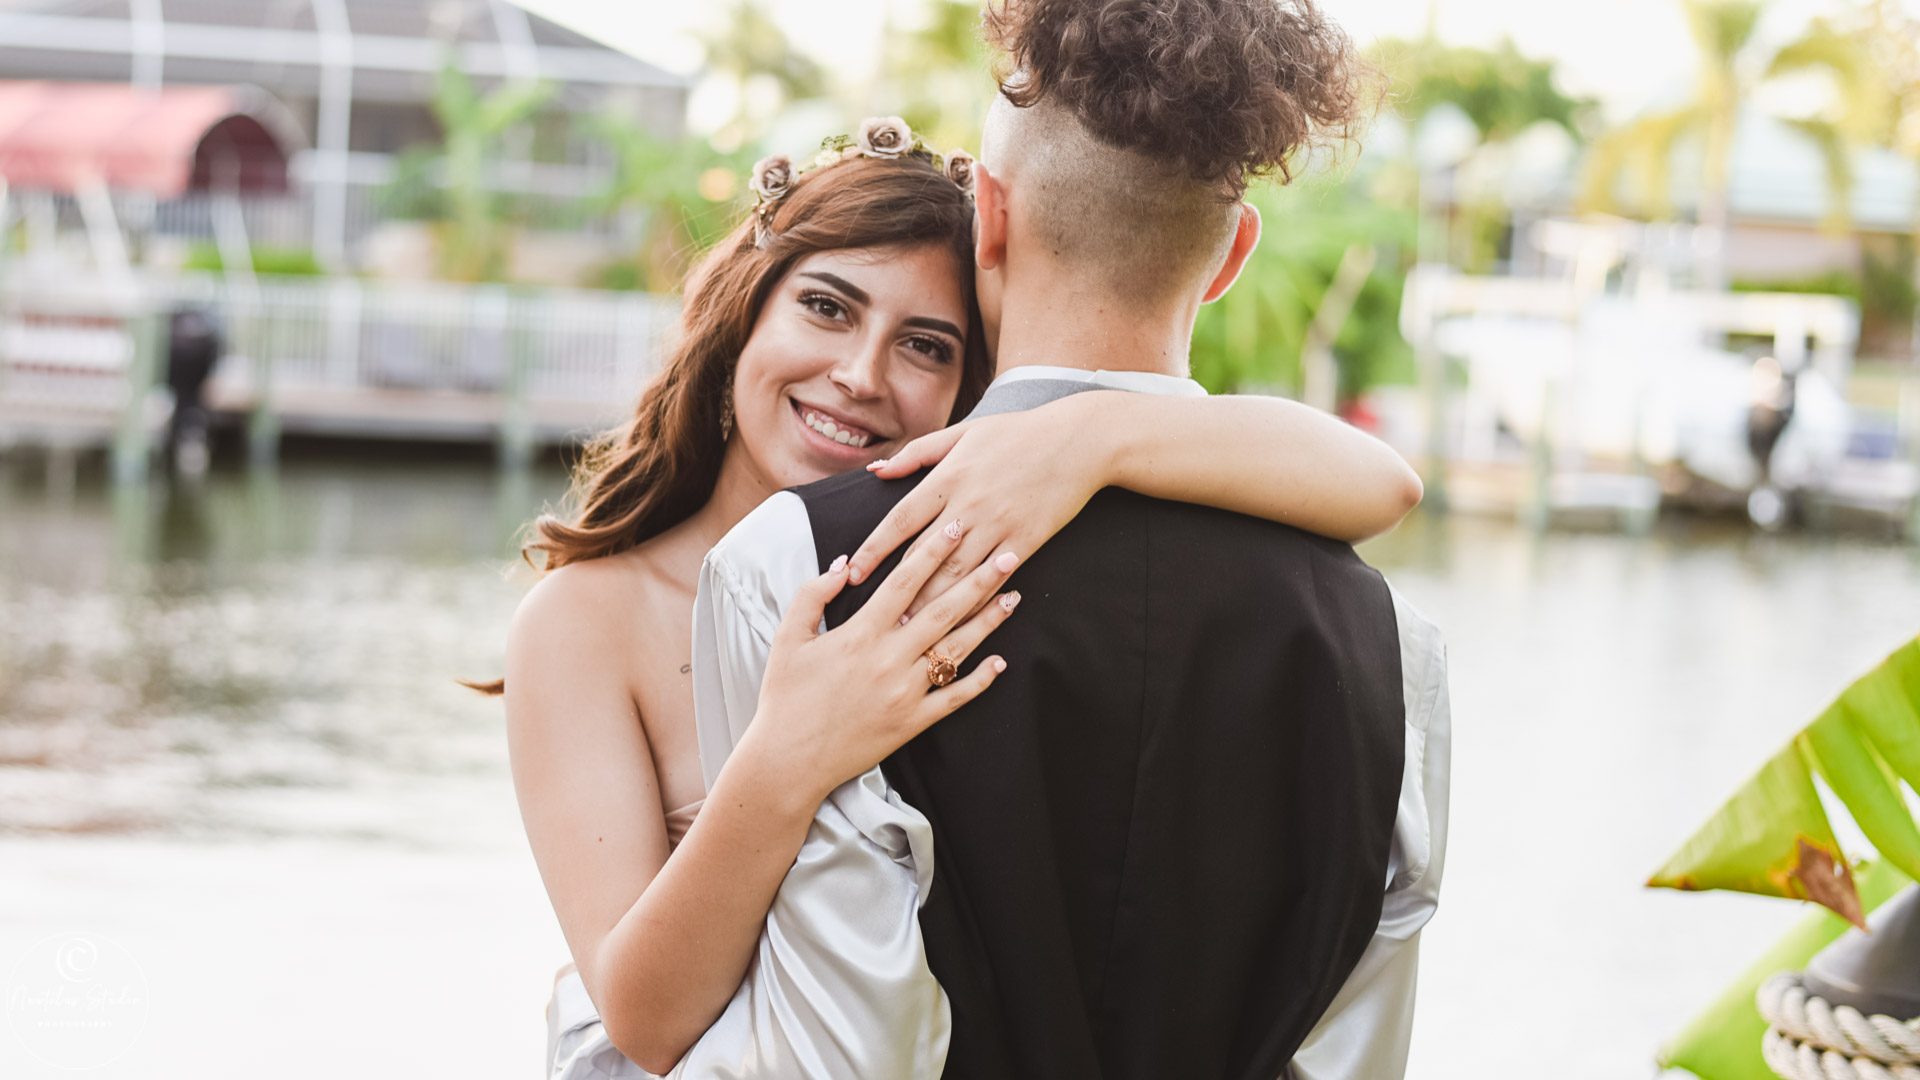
[467,154,993,694]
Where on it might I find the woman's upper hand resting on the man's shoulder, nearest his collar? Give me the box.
[851,392,1105,611]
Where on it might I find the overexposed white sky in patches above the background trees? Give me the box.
[522,0,1866,117]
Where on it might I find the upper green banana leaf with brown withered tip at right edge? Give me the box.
[1647,638,1920,926]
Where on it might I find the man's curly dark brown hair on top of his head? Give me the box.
[983,0,1365,198]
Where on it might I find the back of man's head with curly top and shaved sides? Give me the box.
[983,0,1361,304]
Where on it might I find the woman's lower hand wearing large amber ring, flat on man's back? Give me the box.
[735,521,1020,807]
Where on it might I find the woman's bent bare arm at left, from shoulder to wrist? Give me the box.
[507,565,818,1072]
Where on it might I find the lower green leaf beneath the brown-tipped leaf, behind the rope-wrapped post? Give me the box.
[1661,861,1907,1080]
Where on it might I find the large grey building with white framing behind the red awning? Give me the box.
[0,0,687,269]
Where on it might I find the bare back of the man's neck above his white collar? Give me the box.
[995,270,1194,377]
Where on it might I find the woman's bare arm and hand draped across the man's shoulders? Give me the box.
[852,390,1421,603]
